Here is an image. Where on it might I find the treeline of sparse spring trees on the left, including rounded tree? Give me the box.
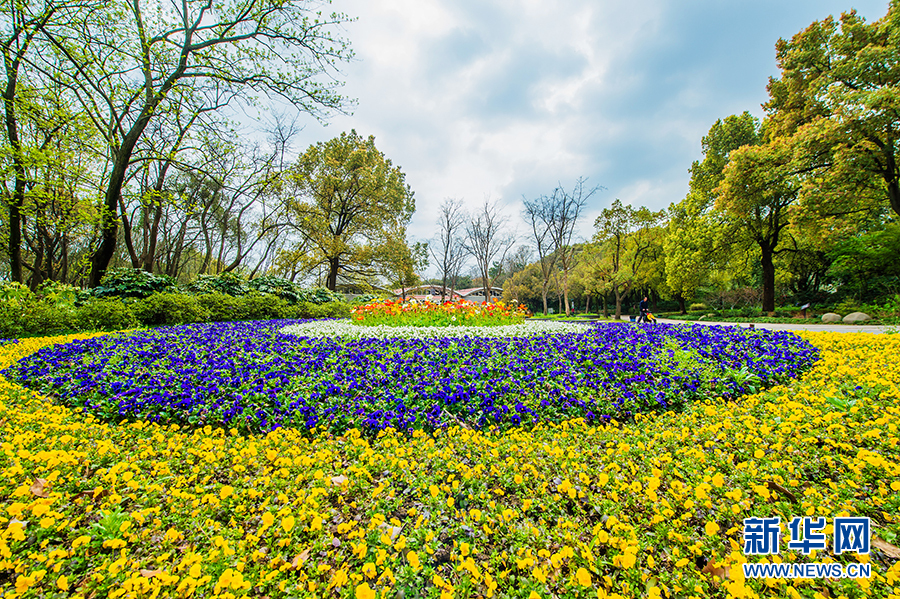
[0,0,430,291]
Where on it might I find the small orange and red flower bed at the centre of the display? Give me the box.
[350,300,530,327]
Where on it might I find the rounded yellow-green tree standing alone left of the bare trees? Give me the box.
[284,131,415,290]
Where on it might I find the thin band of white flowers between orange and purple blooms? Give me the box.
[281,320,587,339]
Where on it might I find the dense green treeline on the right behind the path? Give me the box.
[496,2,900,315]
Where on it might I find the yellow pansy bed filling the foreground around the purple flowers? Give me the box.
[0,333,900,599]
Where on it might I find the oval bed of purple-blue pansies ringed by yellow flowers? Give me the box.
[3,321,818,431]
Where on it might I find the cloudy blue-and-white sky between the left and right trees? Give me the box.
[278,0,888,274]
